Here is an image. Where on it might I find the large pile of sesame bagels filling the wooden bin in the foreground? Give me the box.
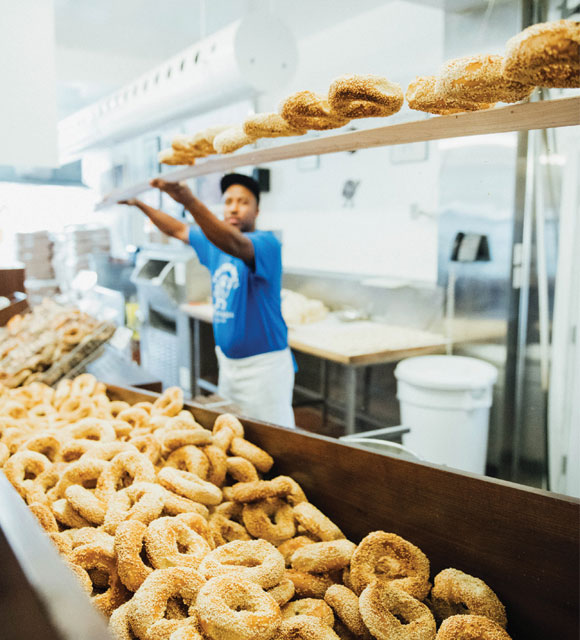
[0,374,510,640]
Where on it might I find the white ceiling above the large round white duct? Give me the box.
[55,0,504,117]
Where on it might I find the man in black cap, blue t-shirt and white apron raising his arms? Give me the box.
[122,173,294,427]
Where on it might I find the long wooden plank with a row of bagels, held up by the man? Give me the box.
[95,96,580,209]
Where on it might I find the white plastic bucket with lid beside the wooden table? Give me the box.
[395,356,497,474]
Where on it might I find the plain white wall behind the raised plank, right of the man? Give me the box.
[257,2,444,282]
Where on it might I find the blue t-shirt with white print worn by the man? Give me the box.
[189,227,288,358]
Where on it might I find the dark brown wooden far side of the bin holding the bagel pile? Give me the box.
[0,386,580,640]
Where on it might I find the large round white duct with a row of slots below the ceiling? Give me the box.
[59,13,298,162]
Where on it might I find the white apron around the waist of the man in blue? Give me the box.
[216,347,296,427]
